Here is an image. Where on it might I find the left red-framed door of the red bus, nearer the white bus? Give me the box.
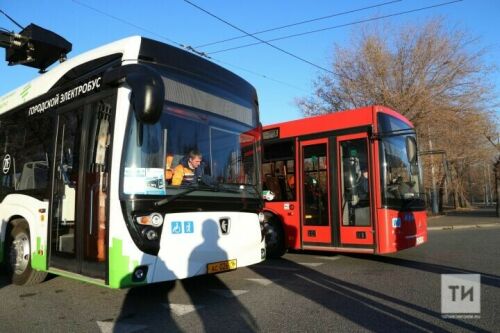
[300,138,332,246]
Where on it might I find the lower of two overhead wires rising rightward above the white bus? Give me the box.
[209,0,463,55]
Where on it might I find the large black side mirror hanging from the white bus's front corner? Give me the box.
[103,64,165,124]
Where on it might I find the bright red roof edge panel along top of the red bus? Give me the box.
[263,105,413,138]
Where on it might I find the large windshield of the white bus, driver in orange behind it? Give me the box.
[122,101,260,197]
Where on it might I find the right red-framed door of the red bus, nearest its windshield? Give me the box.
[337,133,374,247]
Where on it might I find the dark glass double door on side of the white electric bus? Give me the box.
[49,101,111,279]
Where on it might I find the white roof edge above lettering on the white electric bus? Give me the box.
[0,36,141,114]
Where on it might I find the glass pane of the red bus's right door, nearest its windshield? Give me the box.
[340,139,370,226]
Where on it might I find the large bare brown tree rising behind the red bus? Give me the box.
[297,18,498,207]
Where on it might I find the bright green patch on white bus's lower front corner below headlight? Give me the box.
[109,238,146,288]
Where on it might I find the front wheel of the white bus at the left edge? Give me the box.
[6,219,47,286]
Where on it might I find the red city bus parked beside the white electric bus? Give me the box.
[262,105,427,257]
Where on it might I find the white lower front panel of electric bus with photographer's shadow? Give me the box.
[153,212,265,282]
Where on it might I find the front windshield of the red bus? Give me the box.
[378,113,425,210]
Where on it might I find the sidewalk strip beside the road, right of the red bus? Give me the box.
[427,207,500,230]
